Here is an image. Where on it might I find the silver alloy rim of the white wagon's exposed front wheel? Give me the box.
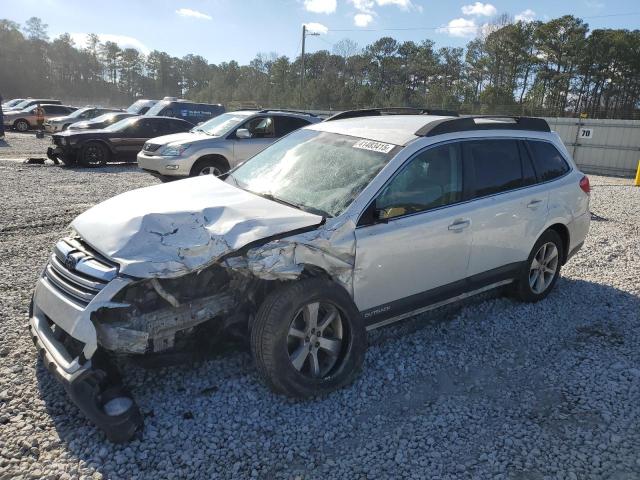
[287,302,346,379]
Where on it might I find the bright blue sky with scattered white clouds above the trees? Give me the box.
[5,0,640,64]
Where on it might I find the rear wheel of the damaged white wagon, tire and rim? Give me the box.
[513,230,564,302]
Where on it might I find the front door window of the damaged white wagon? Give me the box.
[376,143,462,219]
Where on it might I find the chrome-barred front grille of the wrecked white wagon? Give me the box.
[45,238,118,305]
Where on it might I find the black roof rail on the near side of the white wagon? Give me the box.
[415,115,551,137]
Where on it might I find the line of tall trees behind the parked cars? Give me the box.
[0,15,640,118]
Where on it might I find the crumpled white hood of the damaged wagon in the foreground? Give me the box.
[71,176,323,278]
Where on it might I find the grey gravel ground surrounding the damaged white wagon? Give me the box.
[0,158,640,480]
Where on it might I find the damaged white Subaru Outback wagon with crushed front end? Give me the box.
[30,109,590,441]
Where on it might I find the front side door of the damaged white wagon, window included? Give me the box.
[354,143,471,325]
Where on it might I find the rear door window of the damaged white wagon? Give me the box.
[462,140,523,197]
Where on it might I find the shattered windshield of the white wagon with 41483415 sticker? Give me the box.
[227,130,397,217]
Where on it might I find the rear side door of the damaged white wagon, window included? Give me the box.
[462,138,548,283]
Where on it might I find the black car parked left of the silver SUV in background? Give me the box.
[47,117,193,165]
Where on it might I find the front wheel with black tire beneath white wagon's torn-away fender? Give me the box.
[250,278,367,398]
